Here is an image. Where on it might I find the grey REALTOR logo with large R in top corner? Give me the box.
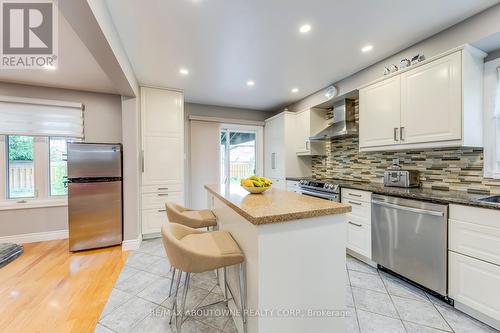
[0,0,57,69]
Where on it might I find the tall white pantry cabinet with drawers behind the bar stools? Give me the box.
[141,87,184,235]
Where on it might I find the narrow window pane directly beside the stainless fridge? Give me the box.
[49,138,72,196]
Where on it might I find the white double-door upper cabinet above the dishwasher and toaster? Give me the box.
[359,46,486,151]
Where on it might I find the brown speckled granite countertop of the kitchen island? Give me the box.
[205,185,352,225]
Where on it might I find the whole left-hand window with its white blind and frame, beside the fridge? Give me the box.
[0,96,84,206]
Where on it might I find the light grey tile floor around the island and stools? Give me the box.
[94,239,498,333]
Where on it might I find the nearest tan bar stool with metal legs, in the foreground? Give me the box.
[161,223,247,333]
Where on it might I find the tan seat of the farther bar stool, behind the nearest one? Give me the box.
[165,202,217,230]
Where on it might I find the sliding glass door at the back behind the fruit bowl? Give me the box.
[220,126,261,185]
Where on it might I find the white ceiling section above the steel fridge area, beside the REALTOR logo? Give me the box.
[0,14,117,94]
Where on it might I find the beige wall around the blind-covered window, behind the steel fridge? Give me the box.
[0,82,122,237]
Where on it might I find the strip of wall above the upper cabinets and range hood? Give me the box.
[288,4,500,112]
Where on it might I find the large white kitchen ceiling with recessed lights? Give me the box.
[106,0,498,109]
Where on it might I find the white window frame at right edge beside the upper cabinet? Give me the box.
[483,58,500,179]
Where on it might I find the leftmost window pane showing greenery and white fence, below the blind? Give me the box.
[7,135,35,199]
